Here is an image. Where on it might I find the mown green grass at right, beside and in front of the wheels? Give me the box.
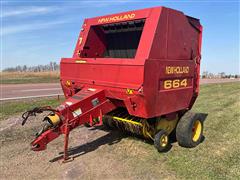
[122,83,240,179]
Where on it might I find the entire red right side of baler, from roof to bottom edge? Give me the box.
[143,8,201,117]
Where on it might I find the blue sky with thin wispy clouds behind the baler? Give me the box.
[0,0,240,74]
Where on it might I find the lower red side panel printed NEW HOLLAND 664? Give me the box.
[156,60,195,115]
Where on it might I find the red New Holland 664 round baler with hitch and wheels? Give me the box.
[23,7,205,160]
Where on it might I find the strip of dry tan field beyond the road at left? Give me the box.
[0,72,59,84]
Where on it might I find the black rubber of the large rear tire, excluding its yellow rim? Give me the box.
[176,112,205,148]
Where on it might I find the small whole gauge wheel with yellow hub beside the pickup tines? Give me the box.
[154,130,172,152]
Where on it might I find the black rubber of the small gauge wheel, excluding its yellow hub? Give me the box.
[154,130,172,152]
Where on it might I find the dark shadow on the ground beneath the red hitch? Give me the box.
[49,126,129,163]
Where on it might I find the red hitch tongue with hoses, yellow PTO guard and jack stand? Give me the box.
[22,89,116,161]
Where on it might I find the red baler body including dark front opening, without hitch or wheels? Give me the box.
[61,7,202,118]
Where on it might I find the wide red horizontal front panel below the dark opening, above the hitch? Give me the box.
[60,62,143,93]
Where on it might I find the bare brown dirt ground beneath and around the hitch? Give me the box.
[0,114,175,179]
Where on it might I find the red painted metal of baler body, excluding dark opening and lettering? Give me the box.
[61,7,202,118]
